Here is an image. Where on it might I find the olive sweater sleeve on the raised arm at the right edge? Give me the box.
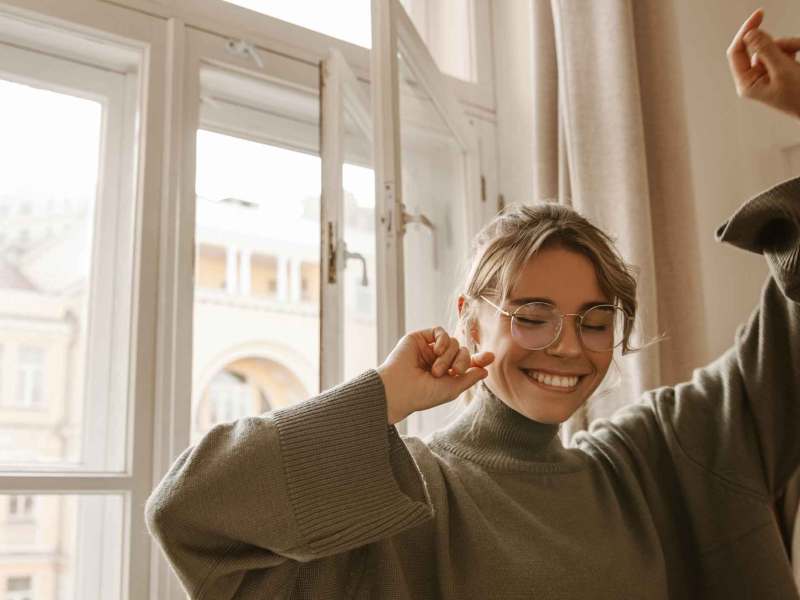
[645,178,800,500]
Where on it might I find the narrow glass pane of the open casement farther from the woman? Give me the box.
[342,86,378,380]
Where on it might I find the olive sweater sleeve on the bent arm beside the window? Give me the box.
[146,370,433,600]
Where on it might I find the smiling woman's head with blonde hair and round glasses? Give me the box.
[450,203,662,423]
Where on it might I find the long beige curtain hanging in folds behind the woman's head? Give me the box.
[531,0,800,587]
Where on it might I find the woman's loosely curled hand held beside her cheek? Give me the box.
[377,327,494,425]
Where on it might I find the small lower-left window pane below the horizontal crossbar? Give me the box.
[0,494,124,600]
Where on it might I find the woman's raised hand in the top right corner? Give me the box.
[727,8,800,117]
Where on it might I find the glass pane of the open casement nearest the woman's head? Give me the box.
[398,52,467,435]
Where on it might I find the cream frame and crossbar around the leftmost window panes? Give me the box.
[0,0,167,598]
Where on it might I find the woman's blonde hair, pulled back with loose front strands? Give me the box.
[450,201,665,402]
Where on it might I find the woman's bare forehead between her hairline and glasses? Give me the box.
[509,247,611,312]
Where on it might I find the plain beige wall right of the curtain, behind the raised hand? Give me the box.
[675,0,800,360]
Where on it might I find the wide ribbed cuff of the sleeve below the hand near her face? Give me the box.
[273,370,433,557]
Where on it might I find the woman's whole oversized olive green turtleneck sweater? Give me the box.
[146,179,800,600]
